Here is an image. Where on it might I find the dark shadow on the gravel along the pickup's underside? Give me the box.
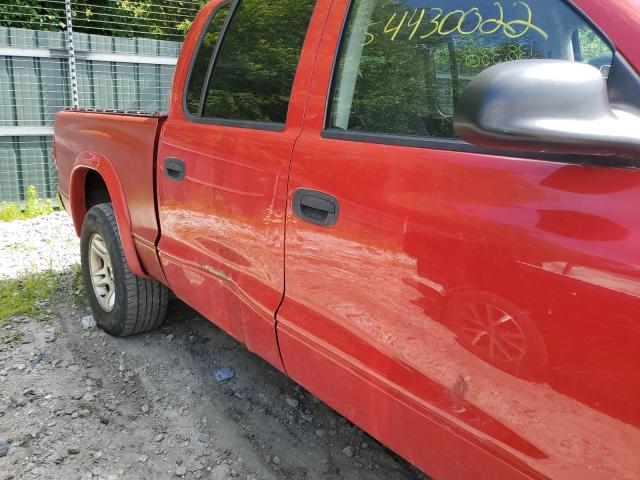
[144,297,428,480]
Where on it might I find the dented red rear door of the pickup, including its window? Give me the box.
[157,0,328,368]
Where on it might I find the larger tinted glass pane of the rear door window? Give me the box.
[204,0,315,123]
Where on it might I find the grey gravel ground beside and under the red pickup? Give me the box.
[0,213,424,480]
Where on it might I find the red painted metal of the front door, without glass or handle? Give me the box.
[278,0,640,480]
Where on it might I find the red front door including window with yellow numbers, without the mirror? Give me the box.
[277,0,640,480]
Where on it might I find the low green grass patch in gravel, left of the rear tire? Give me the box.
[0,270,60,325]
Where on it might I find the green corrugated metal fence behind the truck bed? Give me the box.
[0,27,182,201]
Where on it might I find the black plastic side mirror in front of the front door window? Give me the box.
[454,60,640,157]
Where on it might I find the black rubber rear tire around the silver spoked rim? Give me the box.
[80,203,169,337]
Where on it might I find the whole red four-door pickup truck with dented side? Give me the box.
[55,0,640,480]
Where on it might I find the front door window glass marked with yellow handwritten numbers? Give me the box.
[328,0,612,138]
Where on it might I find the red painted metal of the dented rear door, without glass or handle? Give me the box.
[158,1,329,369]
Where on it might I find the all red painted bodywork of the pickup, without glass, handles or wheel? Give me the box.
[56,0,640,480]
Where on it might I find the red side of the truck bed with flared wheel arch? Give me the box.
[54,110,165,282]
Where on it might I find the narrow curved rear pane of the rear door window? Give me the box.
[186,4,231,116]
